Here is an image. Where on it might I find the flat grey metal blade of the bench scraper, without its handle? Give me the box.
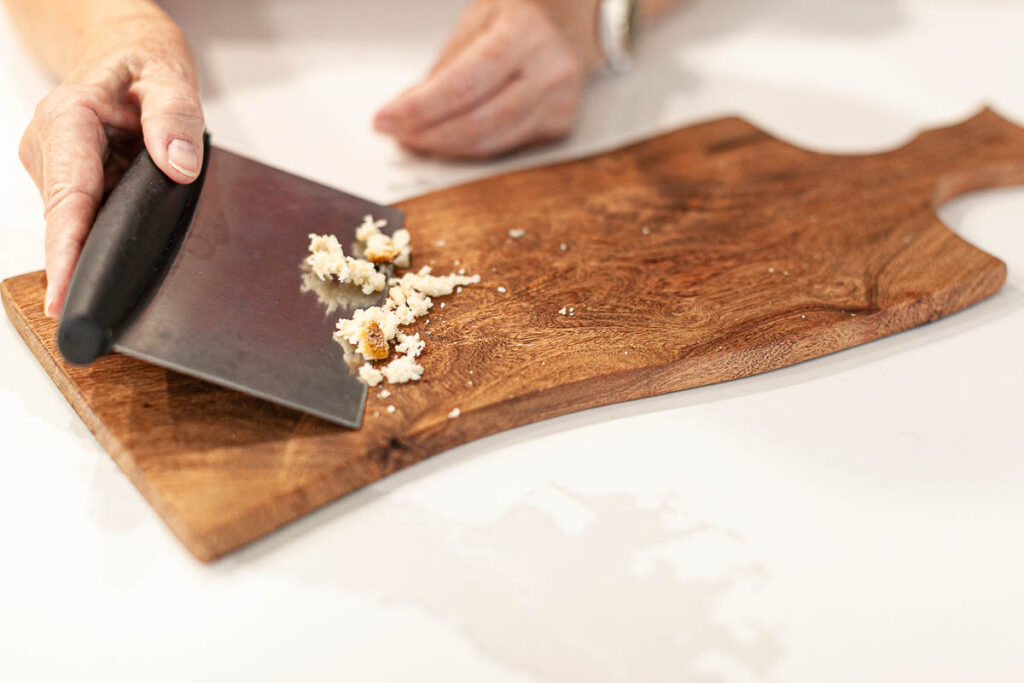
[114,146,404,428]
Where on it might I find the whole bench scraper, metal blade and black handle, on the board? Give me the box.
[57,139,404,428]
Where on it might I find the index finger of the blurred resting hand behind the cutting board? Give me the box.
[374,27,530,133]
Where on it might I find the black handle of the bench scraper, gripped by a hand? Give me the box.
[57,135,210,366]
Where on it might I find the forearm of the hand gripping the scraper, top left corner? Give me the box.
[3,0,173,78]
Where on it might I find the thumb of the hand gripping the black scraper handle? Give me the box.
[133,78,204,183]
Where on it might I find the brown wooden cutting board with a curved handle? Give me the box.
[2,110,1024,560]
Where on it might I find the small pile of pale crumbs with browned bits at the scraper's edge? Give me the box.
[306,216,480,385]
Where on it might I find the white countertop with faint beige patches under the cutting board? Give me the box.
[0,0,1024,683]
